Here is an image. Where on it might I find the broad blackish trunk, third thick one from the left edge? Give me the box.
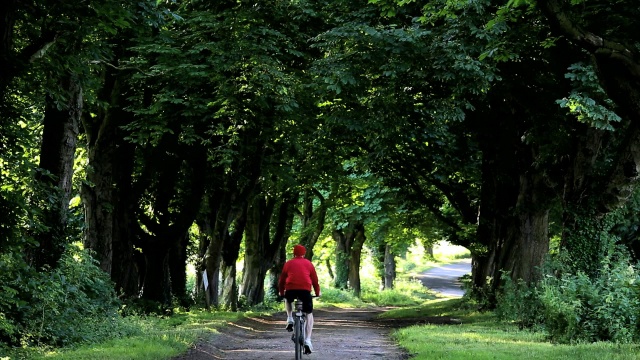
[137,145,206,305]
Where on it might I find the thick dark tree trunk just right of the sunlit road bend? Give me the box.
[472,95,553,307]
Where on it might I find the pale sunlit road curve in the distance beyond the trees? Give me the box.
[415,259,471,297]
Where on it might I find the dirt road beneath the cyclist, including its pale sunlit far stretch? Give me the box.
[174,263,466,360]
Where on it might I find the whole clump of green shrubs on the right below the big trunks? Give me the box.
[496,249,640,343]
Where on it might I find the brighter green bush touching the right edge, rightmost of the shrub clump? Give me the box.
[540,250,640,343]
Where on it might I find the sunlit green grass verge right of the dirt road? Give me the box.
[383,299,640,360]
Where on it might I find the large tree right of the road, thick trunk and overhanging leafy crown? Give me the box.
[319,2,600,302]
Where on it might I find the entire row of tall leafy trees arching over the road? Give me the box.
[0,0,640,348]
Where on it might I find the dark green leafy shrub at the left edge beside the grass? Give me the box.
[0,246,121,346]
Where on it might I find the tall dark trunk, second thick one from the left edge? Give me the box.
[81,47,146,298]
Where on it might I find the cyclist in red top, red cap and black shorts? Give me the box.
[278,245,320,353]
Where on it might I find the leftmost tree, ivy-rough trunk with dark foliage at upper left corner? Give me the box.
[0,1,134,268]
